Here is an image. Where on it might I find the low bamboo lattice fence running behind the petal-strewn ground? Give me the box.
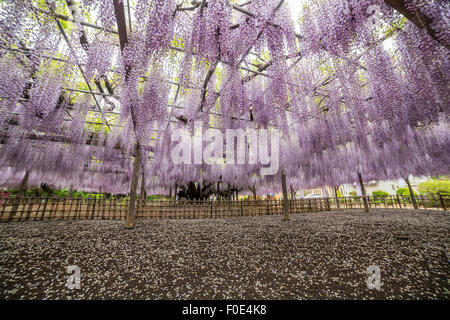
[0,196,450,222]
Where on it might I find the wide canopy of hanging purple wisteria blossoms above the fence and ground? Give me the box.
[0,0,450,194]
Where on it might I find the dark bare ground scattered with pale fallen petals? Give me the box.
[0,209,450,299]
